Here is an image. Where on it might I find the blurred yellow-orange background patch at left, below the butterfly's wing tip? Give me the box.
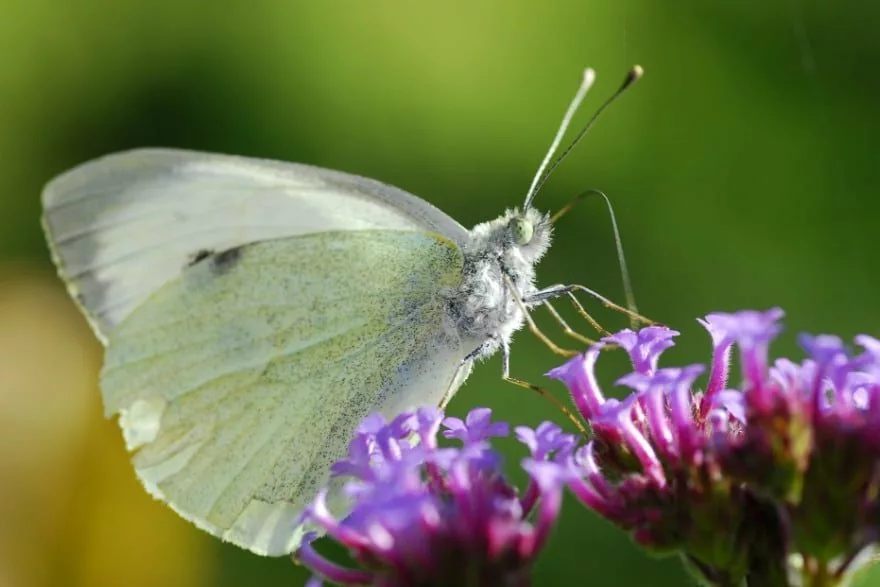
[0,266,211,587]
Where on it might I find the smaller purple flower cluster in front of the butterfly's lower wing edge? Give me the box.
[297,408,575,587]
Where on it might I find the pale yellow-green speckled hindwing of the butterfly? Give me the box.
[101,230,472,555]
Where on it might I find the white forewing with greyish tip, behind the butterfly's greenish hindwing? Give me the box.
[43,149,467,343]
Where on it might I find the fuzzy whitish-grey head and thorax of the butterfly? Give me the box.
[449,208,552,355]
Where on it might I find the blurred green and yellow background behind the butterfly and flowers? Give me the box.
[0,0,880,587]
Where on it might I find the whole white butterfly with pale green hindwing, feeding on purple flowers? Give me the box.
[43,69,640,555]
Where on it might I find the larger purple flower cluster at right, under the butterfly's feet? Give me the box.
[548,309,880,586]
